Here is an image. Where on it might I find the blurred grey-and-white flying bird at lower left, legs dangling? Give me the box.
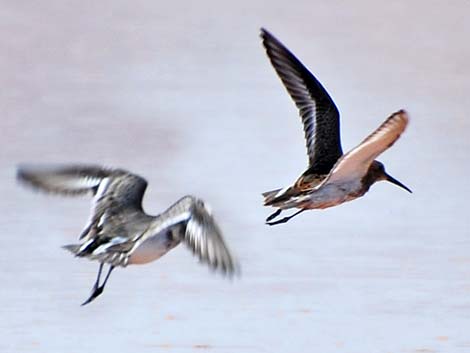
[17,165,239,305]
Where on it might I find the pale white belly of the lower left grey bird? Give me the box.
[129,232,179,265]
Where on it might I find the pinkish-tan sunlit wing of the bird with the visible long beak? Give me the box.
[319,110,409,187]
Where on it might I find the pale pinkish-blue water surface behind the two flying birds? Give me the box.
[0,0,470,353]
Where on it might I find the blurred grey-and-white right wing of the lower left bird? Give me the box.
[152,196,237,276]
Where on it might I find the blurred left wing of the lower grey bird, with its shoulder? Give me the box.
[17,165,147,239]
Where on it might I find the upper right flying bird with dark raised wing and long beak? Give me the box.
[260,28,412,225]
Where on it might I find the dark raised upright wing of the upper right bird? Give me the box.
[261,29,343,174]
